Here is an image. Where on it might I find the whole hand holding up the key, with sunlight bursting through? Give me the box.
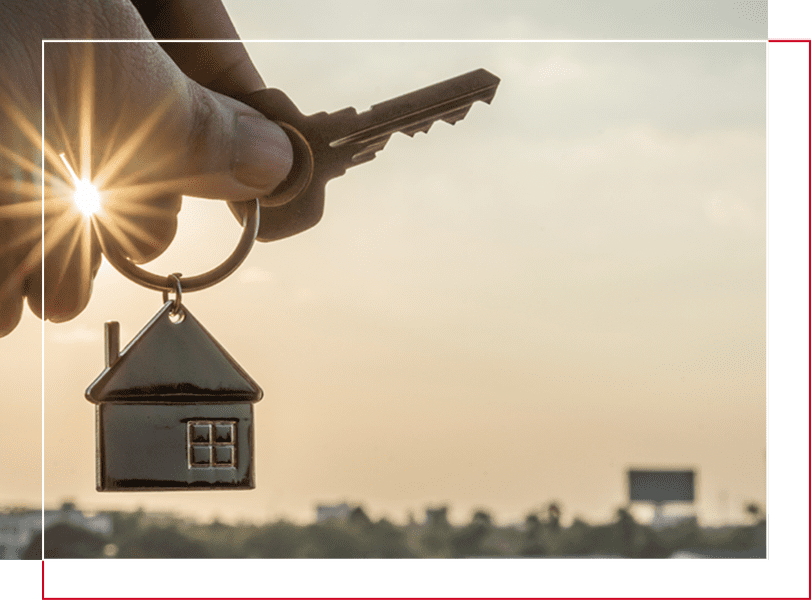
[0,0,293,336]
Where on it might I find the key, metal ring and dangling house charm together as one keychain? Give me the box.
[85,69,500,491]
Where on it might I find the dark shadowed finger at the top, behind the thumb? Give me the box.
[133,0,265,96]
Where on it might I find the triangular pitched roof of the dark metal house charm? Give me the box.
[85,301,262,403]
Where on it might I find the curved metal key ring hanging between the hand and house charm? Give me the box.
[98,199,259,292]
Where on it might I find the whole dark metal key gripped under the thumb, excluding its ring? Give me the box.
[232,68,501,242]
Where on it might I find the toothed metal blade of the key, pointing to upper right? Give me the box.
[330,69,501,165]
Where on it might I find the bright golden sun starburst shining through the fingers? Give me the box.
[0,42,185,304]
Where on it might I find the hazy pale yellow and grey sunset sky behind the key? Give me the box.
[0,0,768,523]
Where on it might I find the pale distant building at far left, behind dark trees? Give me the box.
[0,502,113,560]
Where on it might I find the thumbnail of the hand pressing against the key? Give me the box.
[232,115,293,192]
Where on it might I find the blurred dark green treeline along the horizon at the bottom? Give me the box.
[33,504,766,559]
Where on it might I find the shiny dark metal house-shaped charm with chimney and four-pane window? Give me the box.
[85,300,262,491]
